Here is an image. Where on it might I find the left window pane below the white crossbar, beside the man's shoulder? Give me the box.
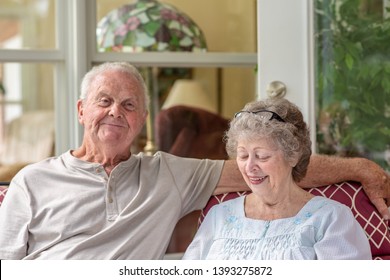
[0,63,54,172]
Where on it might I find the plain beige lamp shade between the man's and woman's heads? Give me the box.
[162,79,217,113]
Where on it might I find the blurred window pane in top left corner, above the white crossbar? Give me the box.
[0,0,56,49]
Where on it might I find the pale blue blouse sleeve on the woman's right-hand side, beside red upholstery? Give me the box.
[314,204,372,260]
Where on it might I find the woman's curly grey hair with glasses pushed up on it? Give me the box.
[224,98,311,182]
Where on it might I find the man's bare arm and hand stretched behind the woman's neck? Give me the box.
[214,155,390,219]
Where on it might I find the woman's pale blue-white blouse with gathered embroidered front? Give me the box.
[183,196,371,260]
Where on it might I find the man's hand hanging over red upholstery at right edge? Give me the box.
[360,160,390,220]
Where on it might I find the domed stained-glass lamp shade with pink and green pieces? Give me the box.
[96,0,207,52]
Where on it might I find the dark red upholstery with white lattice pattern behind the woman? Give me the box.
[199,182,390,260]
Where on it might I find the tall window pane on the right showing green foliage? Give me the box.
[316,0,390,170]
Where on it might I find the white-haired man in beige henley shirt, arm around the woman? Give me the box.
[0,63,390,259]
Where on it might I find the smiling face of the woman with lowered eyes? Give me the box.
[236,138,293,195]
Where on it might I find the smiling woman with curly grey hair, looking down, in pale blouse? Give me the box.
[183,99,371,260]
